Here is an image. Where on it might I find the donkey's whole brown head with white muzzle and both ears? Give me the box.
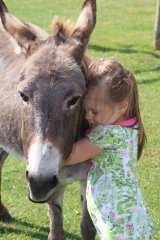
[0,0,96,202]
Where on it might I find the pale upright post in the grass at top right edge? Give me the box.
[154,0,160,50]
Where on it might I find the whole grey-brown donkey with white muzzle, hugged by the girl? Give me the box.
[0,0,96,240]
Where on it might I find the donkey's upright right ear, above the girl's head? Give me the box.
[70,0,96,62]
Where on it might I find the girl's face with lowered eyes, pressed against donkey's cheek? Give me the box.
[84,86,128,127]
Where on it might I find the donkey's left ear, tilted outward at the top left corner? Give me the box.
[0,0,37,52]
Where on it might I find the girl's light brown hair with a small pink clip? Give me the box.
[87,59,146,159]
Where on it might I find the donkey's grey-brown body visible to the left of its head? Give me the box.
[0,30,24,157]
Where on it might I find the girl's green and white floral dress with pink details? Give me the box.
[86,125,154,240]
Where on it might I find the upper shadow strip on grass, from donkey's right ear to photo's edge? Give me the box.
[88,44,160,58]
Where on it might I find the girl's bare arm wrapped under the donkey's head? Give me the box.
[65,137,103,165]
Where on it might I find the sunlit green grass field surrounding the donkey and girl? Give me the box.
[0,0,160,240]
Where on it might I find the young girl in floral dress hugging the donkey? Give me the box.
[66,59,153,240]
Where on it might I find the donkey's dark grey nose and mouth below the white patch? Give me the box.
[26,171,58,203]
